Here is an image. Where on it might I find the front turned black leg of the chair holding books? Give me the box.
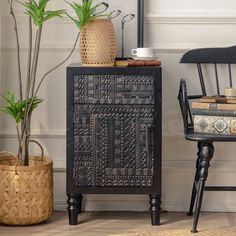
[191,143,214,233]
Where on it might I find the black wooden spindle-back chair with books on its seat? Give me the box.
[178,46,236,233]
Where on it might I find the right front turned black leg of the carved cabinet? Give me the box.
[150,194,161,225]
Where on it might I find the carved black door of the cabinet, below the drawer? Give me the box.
[73,104,154,187]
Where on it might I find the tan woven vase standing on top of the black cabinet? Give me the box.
[80,19,116,67]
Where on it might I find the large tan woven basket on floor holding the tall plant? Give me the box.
[0,156,53,225]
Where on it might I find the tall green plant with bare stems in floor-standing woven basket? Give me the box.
[0,0,79,225]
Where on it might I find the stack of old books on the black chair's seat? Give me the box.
[192,97,236,135]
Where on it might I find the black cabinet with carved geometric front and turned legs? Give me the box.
[67,64,161,225]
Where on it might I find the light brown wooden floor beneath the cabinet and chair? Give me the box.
[0,212,236,236]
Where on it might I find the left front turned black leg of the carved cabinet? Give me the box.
[67,194,82,225]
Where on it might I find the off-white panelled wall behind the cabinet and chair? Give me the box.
[0,0,236,211]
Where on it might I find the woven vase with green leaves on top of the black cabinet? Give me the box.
[68,0,116,67]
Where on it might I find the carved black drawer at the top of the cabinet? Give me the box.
[74,75,154,104]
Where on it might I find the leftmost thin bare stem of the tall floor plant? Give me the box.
[8,0,23,100]
